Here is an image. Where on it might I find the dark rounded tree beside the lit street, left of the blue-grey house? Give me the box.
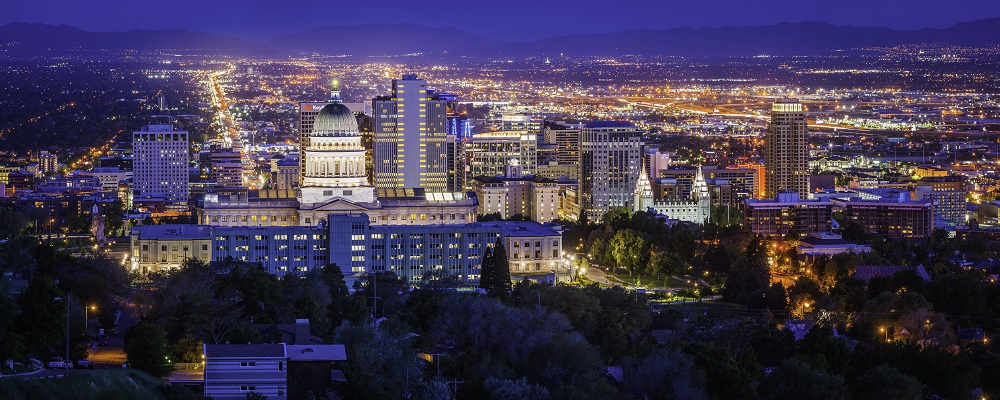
[124,321,174,378]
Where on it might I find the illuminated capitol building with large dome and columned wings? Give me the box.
[198,81,477,226]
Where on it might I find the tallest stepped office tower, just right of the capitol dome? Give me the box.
[372,74,448,192]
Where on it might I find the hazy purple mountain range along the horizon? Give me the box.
[0,18,1000,56]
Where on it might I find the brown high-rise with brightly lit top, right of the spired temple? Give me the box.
[764,98,809,199]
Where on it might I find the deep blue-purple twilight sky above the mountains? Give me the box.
[0,0,1000,41]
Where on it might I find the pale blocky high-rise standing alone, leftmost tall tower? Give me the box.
[132,124,188,210]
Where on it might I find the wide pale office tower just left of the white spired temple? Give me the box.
[577,121,642,221]
